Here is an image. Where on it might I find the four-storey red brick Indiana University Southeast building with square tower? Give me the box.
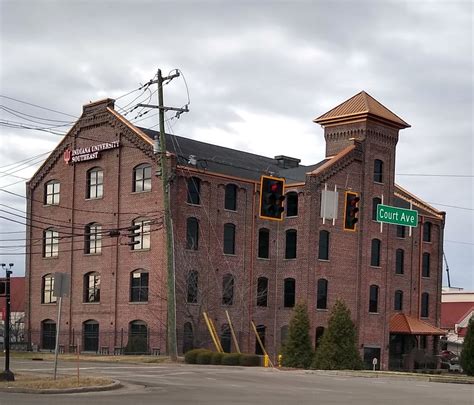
[26,92,445,369]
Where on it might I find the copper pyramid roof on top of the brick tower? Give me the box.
[313,91,410,129]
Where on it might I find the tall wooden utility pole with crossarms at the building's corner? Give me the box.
[138,69,189,361]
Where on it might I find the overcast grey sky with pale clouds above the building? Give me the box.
[0,0,474,290]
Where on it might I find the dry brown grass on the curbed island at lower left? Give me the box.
[0,373,112,389]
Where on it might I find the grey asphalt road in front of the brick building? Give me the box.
[0,359,474,405]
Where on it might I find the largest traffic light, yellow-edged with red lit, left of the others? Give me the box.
[260,176,285,221]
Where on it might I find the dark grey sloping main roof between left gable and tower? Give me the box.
[138,127,326,183]
